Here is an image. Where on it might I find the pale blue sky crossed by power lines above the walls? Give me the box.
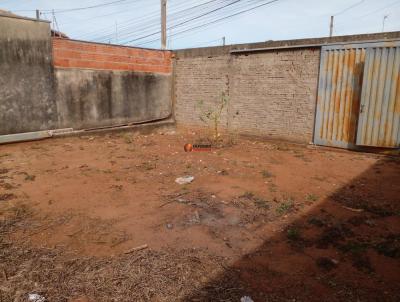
[0,0,400,49]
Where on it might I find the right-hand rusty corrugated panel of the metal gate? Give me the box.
[357,42,400,148]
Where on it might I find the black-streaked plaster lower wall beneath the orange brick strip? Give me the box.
[55,68,172,129]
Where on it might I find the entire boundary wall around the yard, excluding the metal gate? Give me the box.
[0,15,400,142]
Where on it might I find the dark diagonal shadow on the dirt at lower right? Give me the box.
[183,157,400,301]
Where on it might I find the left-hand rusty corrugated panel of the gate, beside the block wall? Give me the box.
[314,44,366,148]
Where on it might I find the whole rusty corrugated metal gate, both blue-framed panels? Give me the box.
[314,41,400,148]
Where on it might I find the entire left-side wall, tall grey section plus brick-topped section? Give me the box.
[0,16,172,135]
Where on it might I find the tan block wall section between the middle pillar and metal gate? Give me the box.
[229,48,320,143]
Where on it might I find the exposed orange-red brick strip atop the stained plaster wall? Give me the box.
[53,38,172,74]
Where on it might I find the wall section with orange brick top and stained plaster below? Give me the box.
[53,38,172,129]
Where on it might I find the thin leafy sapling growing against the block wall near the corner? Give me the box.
[198,92,228,142]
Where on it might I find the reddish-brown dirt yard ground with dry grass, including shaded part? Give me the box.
[0,131,400,302]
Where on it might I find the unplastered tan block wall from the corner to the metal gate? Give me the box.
[175,48,320,143]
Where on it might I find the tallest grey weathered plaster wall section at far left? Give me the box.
[0,16,58,135]
